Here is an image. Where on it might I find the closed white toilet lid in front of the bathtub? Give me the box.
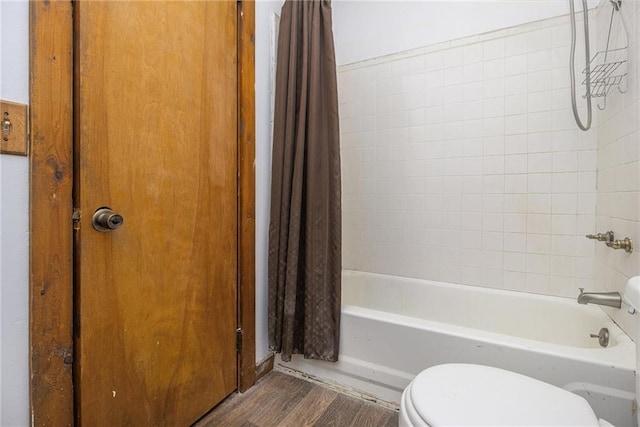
[411,364,599,426]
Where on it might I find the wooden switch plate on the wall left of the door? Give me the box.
[0,101,29,156]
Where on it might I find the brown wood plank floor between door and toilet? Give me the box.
[194,371,398,427]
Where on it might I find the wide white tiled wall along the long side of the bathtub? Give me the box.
[339,10,598,296]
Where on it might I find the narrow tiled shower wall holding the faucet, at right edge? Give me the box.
[595,0,640,336]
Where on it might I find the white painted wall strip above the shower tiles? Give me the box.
[333,0,598,65]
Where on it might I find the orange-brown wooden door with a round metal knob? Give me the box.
[74,1,237,426]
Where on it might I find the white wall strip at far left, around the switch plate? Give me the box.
[0,0,29,426]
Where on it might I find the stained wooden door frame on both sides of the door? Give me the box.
[29,0,256,426]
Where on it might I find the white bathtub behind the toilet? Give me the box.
[276,271,637,427]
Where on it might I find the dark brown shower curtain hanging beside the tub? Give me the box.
[268,0,342,361]
